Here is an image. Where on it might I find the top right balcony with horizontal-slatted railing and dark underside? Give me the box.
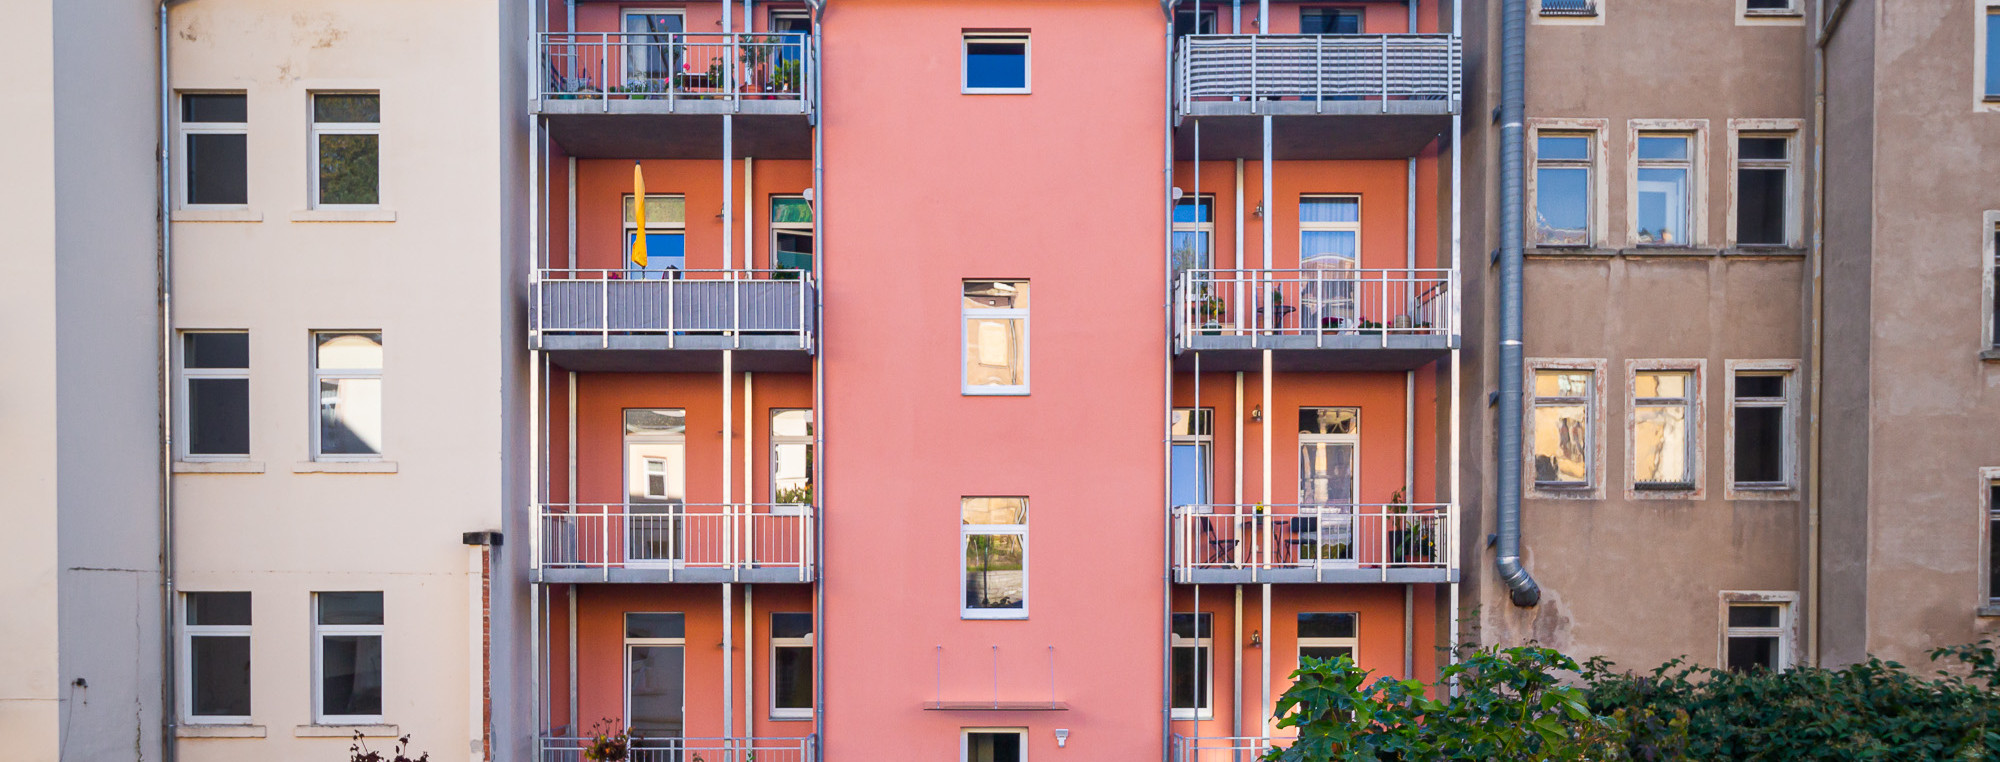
[1174,34,1464,160]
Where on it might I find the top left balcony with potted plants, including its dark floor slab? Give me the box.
[530,32,820,158]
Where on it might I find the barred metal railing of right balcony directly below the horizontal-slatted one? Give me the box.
[1174,268,1458,346]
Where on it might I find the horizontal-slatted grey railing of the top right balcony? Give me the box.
[1176,34,1462,114]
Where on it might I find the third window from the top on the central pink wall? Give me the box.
[958,498,1028,620]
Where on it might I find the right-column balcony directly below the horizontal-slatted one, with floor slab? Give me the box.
[1174,268,1458,370]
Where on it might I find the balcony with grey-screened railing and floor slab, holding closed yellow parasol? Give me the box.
[528,270,818,372]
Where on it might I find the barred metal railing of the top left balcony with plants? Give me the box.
[540,32,818,110]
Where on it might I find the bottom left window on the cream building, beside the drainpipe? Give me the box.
[180,592,250,722]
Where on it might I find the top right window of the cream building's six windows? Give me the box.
[312,92,382,208]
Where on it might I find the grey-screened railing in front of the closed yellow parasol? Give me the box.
[534,270,818,350]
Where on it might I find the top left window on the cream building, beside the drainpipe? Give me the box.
[180,92,250,206]
